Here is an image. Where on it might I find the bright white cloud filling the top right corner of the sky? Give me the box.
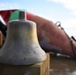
[47,0,76,15]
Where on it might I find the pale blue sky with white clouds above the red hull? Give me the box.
[0,0,76,38]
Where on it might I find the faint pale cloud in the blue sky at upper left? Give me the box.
[0,2,19,10]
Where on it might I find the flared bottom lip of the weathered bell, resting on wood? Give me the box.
[0,53,47,65]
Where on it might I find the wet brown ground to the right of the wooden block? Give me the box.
[50,55,76,75]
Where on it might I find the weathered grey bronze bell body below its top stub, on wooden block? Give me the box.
[0,11,46,65]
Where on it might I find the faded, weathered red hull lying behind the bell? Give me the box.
[2,9,76,56]
